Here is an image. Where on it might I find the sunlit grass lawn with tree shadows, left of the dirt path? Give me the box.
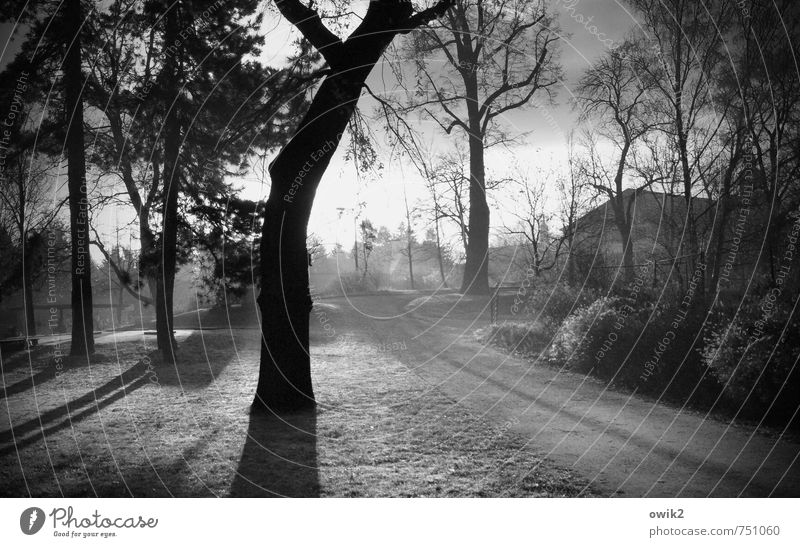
[0,306,582,497]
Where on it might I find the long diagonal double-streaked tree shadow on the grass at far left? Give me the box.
[0,358,157,457]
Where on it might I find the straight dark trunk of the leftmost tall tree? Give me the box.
[64,0,94,356]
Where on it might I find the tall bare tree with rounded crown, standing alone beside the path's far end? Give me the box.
[384,0,560,294]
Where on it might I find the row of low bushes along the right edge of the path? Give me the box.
[484,288,800,425]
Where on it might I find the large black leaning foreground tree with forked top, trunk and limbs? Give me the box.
[254,0,452,410]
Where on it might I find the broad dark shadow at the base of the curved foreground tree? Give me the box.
[230,410,319,498]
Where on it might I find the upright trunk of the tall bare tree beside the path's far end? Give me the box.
[461,121,489,294]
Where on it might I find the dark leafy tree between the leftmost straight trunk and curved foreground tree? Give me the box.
[78,0,310,362]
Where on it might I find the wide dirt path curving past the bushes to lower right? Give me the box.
[339,295,800,497]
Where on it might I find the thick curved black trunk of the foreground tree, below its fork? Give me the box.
[253,41,393,411]
